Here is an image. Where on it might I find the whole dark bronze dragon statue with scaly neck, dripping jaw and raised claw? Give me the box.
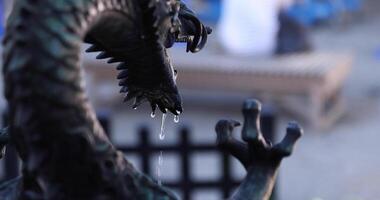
[0,0,301,200]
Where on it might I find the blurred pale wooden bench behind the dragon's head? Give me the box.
[171,50,352,128]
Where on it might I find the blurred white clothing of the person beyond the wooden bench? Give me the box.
[218,0,308,56]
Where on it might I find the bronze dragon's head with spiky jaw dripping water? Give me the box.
[85,0,211,115]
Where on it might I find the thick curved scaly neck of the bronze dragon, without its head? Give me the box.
[3,0,178,199]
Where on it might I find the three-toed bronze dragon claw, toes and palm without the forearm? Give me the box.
[215,99,303,169]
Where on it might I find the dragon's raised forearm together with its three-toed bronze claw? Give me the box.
[215,99,303,200]
